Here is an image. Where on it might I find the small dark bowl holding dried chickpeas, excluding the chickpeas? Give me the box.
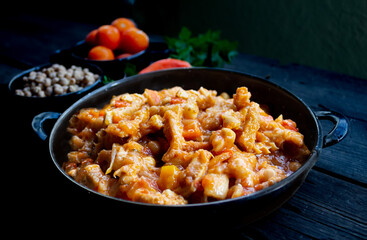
[8,62,103,116]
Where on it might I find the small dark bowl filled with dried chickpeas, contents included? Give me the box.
[8,60,103,113]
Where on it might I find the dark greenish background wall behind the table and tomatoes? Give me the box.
[0,0,367,79]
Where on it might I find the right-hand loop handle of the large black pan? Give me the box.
[315,110,349,148]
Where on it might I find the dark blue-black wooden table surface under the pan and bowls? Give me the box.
[0,15,367,239]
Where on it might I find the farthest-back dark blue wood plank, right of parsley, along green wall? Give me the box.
[225,54,367,119]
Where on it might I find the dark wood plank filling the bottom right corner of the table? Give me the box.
[244,170,367,239]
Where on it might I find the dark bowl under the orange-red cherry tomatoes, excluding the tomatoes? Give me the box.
[51,40,169,80]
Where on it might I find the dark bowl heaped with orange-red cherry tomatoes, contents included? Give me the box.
[51,18,169,80]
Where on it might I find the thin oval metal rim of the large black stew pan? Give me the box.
[49,67,322,208]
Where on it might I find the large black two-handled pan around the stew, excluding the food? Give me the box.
[32,68,348,223]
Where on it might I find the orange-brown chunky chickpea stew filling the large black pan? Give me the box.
[63,87,310,205]
